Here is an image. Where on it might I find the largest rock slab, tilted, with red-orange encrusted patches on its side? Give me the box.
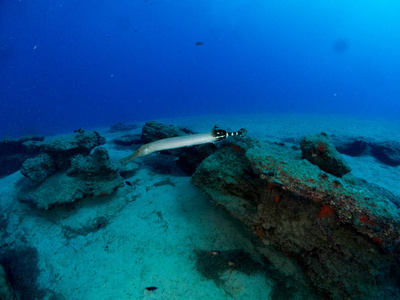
[192,139,400,299]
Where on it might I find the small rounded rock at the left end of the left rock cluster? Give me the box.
[21,153,56,183]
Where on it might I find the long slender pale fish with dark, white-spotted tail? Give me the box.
[121,126,247,164]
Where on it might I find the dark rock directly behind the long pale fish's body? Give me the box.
[141,121,216,175]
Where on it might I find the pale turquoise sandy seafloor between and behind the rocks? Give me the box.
[0,115,400,299]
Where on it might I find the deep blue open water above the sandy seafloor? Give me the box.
[0,0,400,136]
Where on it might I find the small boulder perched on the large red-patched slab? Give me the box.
[300,133,351,177]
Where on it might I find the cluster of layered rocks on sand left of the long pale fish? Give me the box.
[18,131,136,209]
